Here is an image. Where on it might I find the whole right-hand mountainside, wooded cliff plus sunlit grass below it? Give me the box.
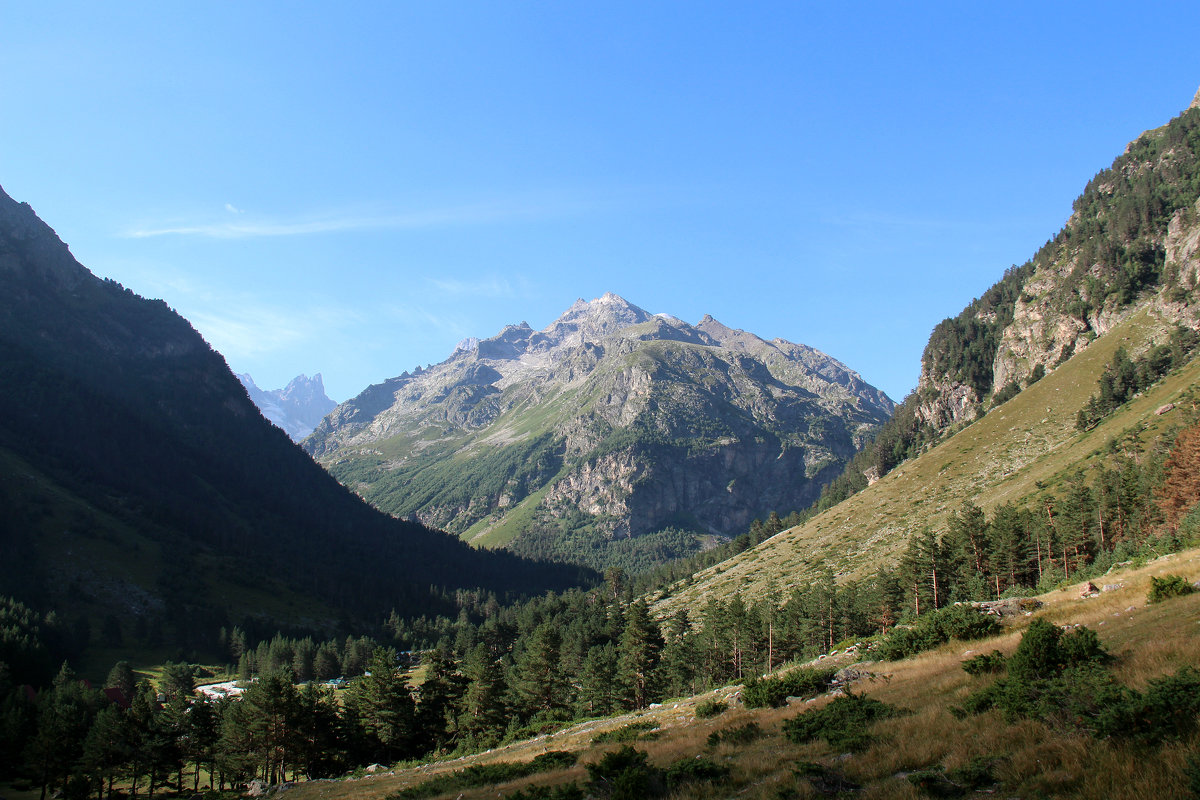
[660,87,1200,610]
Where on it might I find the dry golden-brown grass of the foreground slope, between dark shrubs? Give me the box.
[288,549,1200,800]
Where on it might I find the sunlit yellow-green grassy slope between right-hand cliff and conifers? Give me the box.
[655,304,1200,615]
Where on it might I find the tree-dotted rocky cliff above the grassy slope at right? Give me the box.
[916,92,1200,431]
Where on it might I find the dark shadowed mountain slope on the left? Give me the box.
[0,192,580,657]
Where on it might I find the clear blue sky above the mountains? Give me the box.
[0,1,1200,401]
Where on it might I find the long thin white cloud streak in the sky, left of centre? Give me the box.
[124,200,580,239]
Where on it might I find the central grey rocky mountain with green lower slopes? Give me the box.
[304,294,894,567]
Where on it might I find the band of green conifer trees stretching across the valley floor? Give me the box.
[9,410,1200,799]
